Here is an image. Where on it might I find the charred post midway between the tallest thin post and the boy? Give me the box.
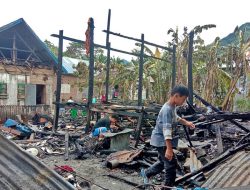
[138,34,144,106]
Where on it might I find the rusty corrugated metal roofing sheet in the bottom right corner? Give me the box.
[203,151,250,189]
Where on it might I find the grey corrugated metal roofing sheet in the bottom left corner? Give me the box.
[0,134,75,190]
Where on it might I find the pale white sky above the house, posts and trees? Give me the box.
[0,0,250,58]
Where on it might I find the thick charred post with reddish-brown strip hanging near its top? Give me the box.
[85,18,94,132]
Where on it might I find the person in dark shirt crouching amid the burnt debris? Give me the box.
[92,115,119,137]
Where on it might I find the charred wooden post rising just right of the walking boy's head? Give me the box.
[188,31,194,105]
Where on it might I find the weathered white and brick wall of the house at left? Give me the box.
[0,65,82,105]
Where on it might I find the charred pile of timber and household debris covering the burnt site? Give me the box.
[0,95,250,189]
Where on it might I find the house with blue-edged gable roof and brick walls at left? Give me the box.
[0,18,82,105]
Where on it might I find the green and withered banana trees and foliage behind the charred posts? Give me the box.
[45,23,250,110]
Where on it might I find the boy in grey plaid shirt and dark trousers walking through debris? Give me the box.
[141,85,195,186]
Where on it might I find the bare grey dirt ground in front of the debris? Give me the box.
[40,155,142,190]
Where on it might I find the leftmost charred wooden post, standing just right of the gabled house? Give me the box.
[52,30,63,132]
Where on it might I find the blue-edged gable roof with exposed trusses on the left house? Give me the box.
[0,18,67,73]
